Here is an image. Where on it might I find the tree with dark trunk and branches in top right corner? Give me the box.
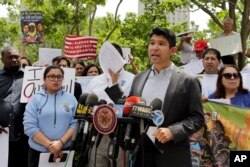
[190,0,250,69]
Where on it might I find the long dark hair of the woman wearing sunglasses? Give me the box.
[215,64,248,98]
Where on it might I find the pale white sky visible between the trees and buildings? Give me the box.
[0,0,209,30]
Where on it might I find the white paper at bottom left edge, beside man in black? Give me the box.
[0,128,9,167]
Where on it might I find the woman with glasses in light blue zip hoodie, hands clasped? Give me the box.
[23,66,77,167]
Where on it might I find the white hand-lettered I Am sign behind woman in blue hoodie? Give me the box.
[20,66,75,103]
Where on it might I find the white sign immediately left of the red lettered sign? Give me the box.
[38,48,62,66]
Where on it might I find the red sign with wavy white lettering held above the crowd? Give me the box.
[64,35,98,60]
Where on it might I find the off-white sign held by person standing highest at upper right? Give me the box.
[210,33,242,56]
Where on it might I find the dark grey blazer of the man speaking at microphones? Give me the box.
[130,69,204,167]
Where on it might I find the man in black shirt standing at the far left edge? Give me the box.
[0,46,28,167]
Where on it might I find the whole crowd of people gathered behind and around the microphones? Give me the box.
[0,18,250,167]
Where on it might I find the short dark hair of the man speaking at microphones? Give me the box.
[149,27,176,48]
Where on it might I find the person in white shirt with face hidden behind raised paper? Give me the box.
[86,44,134,167]
